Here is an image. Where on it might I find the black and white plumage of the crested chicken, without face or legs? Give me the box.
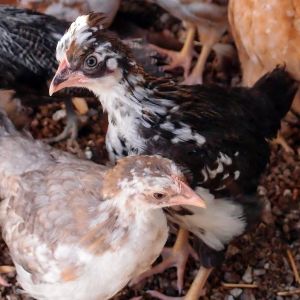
[58,18,296,266]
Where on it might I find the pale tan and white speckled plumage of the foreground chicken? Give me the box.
[0,113,190,300]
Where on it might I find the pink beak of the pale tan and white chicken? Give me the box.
[169,180,206,208]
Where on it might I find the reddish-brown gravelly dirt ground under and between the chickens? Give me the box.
[0,1,300,300]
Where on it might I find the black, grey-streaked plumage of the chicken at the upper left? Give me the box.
[0,5,92,106]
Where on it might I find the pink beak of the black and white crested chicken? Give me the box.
[49,58,87,96]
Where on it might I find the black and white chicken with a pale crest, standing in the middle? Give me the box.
[50,14,296,300]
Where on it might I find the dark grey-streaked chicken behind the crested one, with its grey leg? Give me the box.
[0,6,164,152]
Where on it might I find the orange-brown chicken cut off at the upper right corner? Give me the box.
[228,0,300,151]
